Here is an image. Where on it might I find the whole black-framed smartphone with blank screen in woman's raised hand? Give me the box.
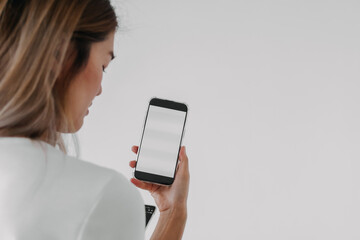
[134,98,188,185]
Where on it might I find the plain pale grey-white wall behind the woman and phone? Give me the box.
[74,0,360,240]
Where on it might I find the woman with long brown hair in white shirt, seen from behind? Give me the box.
[0,0,189,240]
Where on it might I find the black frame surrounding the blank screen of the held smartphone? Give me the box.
[134,98,188,185]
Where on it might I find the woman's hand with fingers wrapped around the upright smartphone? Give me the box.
[129,146,190,214]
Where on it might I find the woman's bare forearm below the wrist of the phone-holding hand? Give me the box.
[151,207,187,240]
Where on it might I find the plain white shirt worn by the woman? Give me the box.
[0,138,145,240]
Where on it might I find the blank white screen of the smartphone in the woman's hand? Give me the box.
[136,105,186,178]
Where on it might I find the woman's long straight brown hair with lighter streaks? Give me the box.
[0,0,117,152]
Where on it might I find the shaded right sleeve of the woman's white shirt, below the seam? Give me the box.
[78,172,145,240]
